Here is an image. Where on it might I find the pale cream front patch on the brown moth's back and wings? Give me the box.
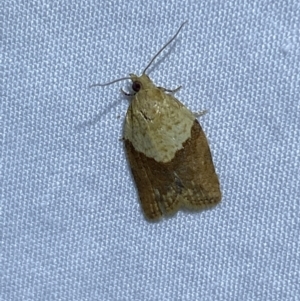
[124,88,195,163]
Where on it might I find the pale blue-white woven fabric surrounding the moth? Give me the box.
[0,0,300,301]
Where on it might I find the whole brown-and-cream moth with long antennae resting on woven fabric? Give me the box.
[93,22,221,220]
